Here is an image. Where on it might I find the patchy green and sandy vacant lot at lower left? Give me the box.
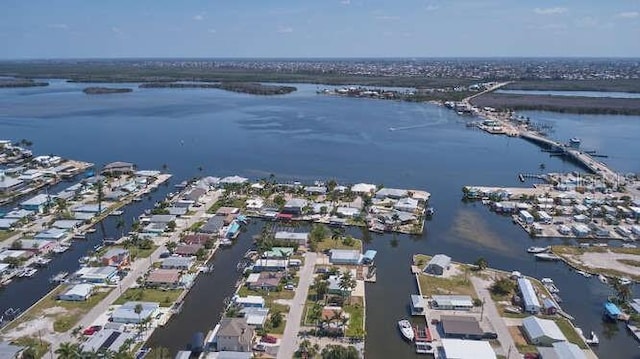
[4,285,112,333]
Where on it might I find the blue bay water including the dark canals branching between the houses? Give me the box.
[0,81,640,358]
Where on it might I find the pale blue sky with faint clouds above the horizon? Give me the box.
[0,0,640,59]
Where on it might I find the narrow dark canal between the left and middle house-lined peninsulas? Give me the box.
[146,220,263,355]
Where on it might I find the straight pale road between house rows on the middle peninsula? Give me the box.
[278,252,318,359]
